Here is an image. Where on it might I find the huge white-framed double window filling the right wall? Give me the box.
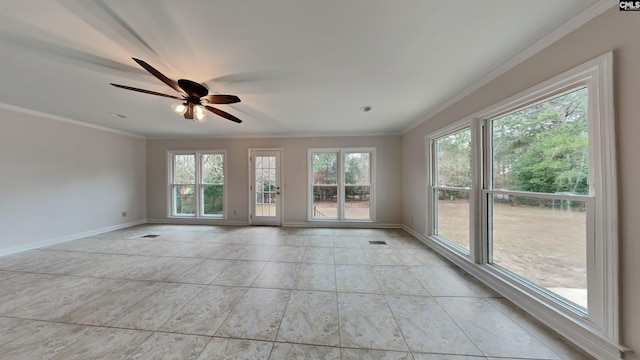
[427,54,619,352]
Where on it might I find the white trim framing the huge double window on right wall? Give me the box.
[425,52,628,359]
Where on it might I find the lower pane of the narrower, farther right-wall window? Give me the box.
[435,189,470,251]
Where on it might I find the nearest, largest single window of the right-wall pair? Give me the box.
[485,86,595,311]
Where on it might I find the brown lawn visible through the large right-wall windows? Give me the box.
[438,200,587,306]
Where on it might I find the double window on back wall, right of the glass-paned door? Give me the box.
[309,148,374,221]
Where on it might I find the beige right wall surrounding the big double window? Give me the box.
[402,7,640,360]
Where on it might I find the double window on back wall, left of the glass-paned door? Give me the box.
[169,151,225,218]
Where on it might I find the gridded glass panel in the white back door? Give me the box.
[254,156,279,216]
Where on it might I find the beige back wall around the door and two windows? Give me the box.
[147,136,402,225]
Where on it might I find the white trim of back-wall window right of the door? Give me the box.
[307,147,377,223]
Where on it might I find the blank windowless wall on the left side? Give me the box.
[0,109,146,255]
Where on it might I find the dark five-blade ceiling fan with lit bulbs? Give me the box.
[110,58,242,123]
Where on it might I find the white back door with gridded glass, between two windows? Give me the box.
[249,150,282,226]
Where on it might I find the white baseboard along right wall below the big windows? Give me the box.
[402,225,629,360]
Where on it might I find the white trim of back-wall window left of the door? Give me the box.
[167,149,228,220]
